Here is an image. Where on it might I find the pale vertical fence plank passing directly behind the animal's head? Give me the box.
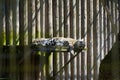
[76,0,82,80]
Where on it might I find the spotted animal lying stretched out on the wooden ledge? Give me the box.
[31,37,85,52]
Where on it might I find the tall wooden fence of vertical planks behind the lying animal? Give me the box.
[0,0,120,80]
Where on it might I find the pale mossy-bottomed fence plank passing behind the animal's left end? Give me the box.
[34,0,43,80]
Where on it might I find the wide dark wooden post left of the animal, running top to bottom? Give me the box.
[19,0,28,80]
